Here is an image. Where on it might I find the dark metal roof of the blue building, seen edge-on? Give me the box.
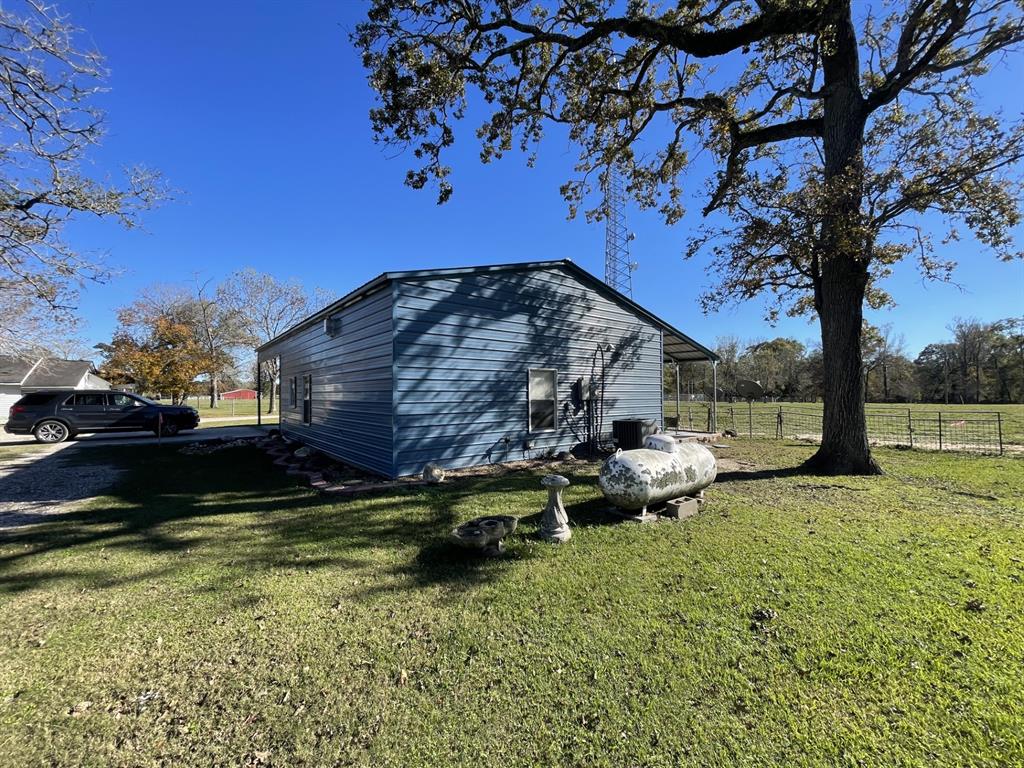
[256,259,718,362]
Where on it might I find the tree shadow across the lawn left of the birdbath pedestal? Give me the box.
[0,446,593,593]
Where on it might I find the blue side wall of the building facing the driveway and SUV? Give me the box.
[260,286,394,476]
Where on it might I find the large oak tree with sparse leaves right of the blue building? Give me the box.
[354,0,1024,473]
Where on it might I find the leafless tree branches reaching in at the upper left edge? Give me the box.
[0,0,165,354]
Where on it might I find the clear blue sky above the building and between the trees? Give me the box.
[60,0,1024,356]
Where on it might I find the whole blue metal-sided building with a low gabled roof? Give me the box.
[257,260,717,477]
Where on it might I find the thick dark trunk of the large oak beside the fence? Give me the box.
[805,0,882,474]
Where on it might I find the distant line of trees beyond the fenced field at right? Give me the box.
[665,317,1024,403]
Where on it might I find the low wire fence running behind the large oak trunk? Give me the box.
[669,403,1006,456]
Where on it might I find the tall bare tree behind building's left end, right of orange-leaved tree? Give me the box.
[217,268,334,414]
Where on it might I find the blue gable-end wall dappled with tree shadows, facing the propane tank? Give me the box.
[394,269,662,475]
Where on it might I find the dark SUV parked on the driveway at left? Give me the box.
[4,389,199,442]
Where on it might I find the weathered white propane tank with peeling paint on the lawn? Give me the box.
[597,434,718,510]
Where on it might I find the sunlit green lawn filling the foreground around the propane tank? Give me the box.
[0,440,1024,767]
